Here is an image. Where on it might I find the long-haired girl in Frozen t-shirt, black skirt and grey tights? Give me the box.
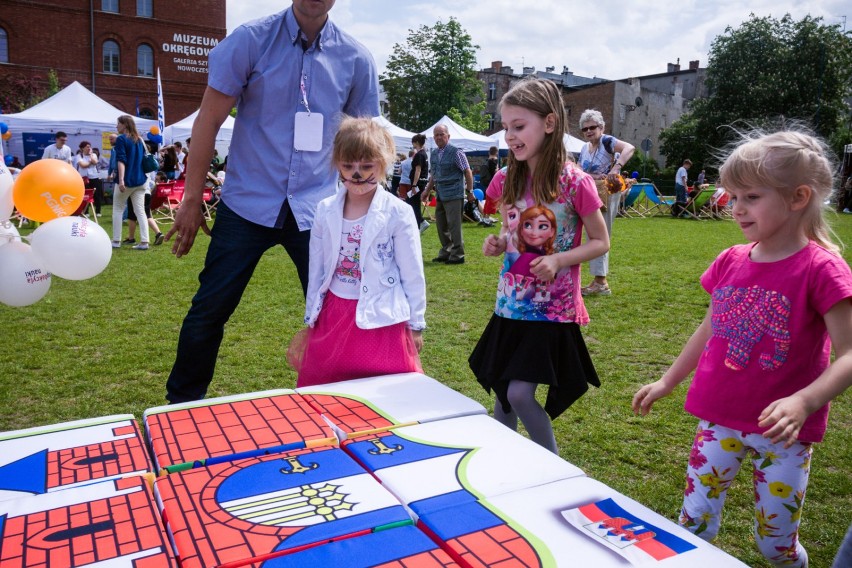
[468,79,609,453]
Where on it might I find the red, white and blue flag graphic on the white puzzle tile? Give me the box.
[562,499,696,566]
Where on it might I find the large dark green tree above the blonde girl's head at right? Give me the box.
[661,14,852,170]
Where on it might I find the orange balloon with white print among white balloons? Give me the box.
[12,158,85,222]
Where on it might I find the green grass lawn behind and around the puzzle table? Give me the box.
[0,207,852,567]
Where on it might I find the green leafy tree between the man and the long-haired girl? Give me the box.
[380,18,485,132]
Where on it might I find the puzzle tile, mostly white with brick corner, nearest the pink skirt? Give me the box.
[296,373,488,439]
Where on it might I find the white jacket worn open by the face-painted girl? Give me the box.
[305,186,426,330]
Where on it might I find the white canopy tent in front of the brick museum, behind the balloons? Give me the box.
[0,81,157,163]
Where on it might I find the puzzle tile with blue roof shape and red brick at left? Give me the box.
[0,414,151,501]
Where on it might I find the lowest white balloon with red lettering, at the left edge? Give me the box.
[0,241,50,308]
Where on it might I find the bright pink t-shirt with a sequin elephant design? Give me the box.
[684,242,852,442]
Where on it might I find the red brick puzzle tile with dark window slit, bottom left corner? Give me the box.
[0,474,175,568]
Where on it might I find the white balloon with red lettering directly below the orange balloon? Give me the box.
[30,215,112,280]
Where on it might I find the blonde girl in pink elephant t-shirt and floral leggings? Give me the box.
[633,131,852,566]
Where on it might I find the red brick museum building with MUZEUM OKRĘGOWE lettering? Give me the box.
[0,0,226,123]
